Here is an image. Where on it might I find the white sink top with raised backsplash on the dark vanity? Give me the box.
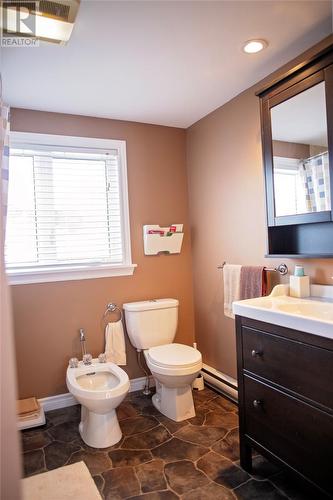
[233,285,333,338]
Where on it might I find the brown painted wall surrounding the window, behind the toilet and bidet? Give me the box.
[11,109,194,397]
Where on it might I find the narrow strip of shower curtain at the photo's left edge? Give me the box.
[0,101,9,235]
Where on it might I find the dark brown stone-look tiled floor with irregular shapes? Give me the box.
[22,388,313,500]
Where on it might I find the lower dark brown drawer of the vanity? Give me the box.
[244,376,333,494]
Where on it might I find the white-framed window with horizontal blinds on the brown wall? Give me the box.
[5,133,135,284]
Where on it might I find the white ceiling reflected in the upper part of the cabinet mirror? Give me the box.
[271,82,328,147]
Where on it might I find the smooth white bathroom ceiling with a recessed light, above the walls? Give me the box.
[2,0,332,128]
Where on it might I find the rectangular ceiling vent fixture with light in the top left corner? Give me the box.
[1,0,80,44]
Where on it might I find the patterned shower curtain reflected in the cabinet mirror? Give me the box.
[299,152,331,212]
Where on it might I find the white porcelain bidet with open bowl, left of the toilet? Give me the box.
[66,359,130,448]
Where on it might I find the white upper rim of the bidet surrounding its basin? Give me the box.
[67,359,130,400]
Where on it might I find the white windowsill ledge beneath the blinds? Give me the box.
[7,264,137,285]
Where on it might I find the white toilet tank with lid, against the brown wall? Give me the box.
[123,299,179,349]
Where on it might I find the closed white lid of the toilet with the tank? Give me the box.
[148,344,201,368]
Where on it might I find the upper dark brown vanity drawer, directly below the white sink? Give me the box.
[242,327,333,409]
